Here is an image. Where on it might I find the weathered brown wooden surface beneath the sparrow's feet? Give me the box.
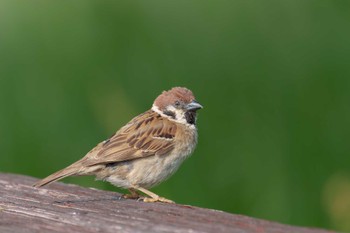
[0,173,336,233]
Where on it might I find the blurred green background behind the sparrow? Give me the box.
[0,0,350,231]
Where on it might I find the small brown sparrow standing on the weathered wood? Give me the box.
[33,87,203,203]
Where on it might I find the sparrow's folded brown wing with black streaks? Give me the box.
[81,110,177,166]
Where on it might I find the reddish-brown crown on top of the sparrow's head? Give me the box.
[154,87,195,110]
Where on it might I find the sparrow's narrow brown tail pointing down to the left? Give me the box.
[33,161,81,187]
